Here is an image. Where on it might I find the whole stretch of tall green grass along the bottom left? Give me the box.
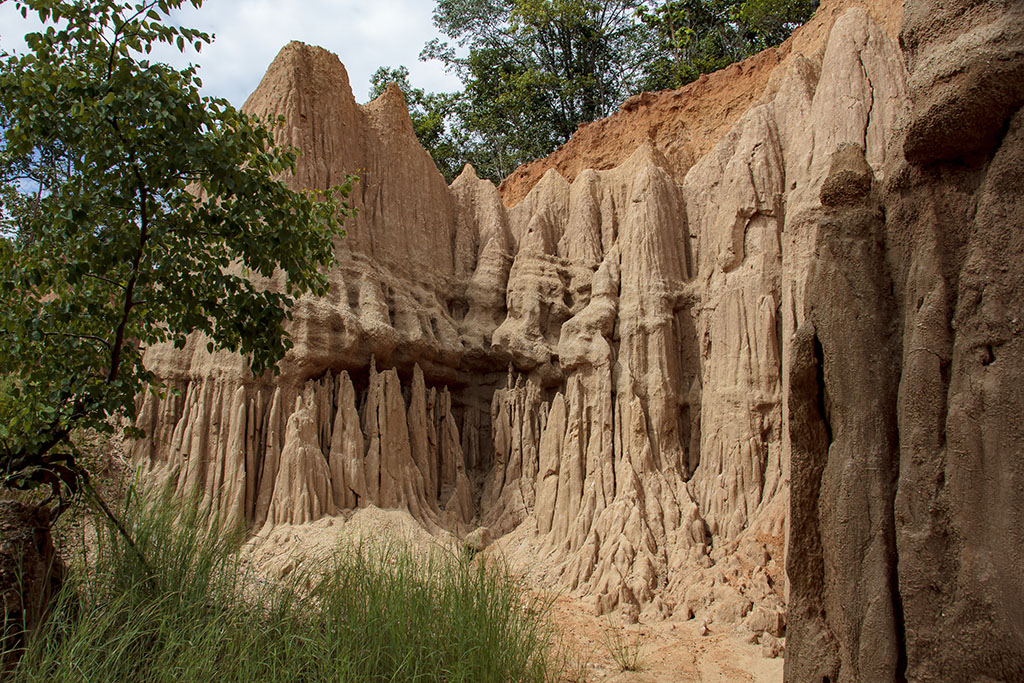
[12,489,562,683]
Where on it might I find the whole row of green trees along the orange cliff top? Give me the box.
[371,0,817,182]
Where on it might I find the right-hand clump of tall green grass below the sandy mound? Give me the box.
[312,544,549,681]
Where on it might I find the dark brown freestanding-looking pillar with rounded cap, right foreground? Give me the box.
[786,144,905,681]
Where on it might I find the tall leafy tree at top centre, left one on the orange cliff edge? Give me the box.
[421,0,652,181]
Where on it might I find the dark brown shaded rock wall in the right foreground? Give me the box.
[786,0,1024,681]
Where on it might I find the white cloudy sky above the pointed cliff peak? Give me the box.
[0,0,459,105]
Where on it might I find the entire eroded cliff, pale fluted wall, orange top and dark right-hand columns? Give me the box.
[133,0,1024,681]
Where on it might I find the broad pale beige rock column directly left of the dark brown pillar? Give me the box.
[685,105,785,541]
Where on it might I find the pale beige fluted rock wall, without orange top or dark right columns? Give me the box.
[128,1,903,634]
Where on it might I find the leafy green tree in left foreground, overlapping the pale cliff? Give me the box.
[0,0,353,511]
